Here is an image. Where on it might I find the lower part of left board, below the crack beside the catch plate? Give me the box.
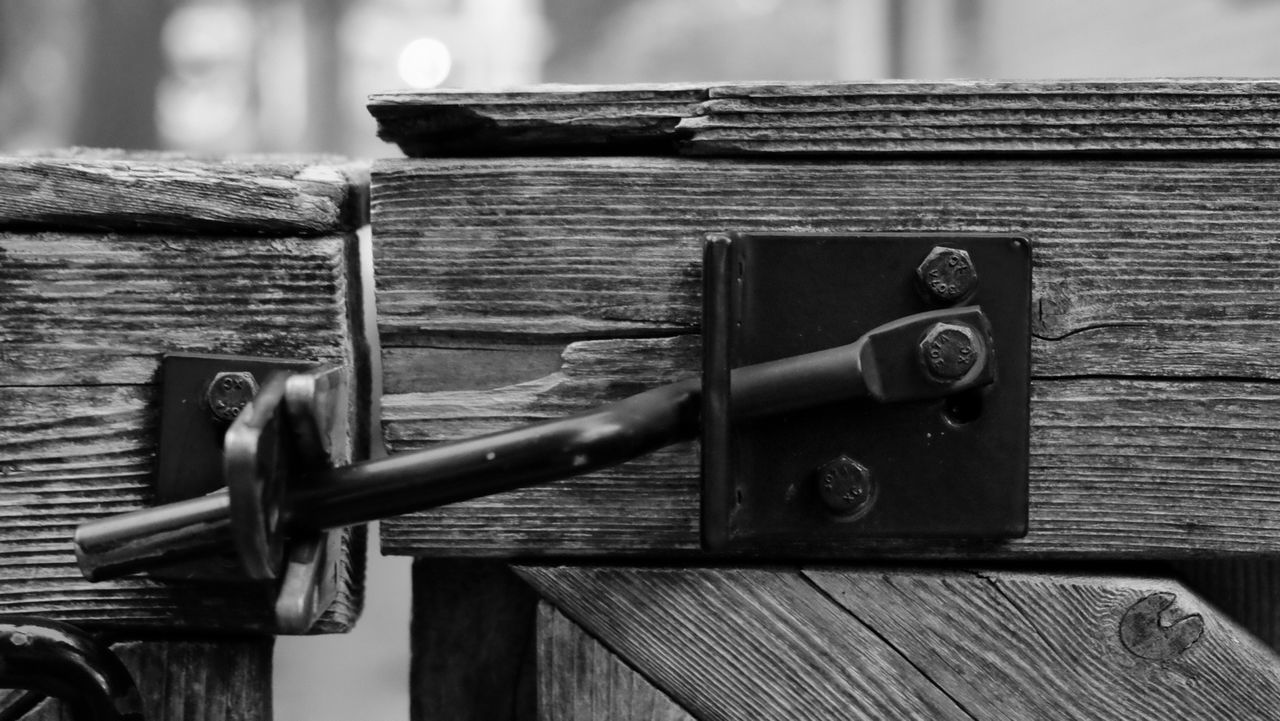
[0,385,365,631]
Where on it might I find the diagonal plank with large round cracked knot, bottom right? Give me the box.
[805,570,1280,720]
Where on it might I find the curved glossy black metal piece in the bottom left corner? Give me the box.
[0,616,143,721]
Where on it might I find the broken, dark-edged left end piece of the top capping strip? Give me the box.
[369,85,707,158]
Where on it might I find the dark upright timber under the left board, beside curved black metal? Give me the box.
[24,638,274,721]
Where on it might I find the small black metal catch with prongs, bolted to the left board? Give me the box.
[104,353,347,634]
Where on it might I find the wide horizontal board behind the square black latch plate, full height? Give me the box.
[372,159,1280,556]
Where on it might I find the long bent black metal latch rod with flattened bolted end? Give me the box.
[76,306,995,580]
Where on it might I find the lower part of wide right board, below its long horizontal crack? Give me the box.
[381,337,1280,557]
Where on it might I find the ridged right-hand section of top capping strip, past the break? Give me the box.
[680,79,1280,155]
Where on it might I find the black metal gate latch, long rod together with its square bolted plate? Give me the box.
[76,234,1030,588]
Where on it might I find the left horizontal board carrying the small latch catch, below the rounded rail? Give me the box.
[0,232,367,630]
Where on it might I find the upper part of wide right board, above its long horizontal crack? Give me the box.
[372,159,1280,388]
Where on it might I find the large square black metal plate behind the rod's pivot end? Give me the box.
[703,233,1030,556]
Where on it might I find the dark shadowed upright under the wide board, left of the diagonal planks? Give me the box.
[410,558,538,721]
